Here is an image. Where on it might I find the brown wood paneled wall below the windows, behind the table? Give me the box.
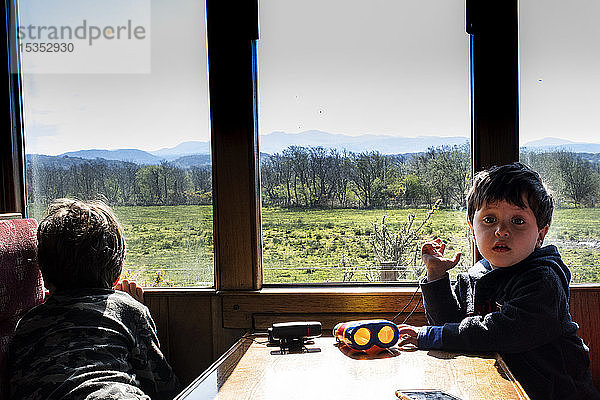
[145,286,600,387]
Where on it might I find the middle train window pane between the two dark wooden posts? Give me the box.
[257,0,471,284]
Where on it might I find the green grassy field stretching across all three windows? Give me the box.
[109,206,600,286]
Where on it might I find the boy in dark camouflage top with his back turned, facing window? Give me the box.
[9,199,178,400]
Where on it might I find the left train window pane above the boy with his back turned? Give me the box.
[17,0,214,286]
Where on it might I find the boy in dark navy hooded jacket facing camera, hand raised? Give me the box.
[400,163,600,400]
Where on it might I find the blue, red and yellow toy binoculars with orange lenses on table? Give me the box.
[333,319,400,354]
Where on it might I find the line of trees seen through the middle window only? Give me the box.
[261,143,470,208]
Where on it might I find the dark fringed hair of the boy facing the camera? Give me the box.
[467,162,554,229]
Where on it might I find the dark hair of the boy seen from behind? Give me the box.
[37,199,126,289]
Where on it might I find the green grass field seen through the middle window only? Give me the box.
[263,208,470,283]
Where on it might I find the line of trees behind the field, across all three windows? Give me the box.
[27,143,600,208]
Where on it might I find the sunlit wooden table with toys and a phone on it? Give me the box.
[176,335,529,400]
